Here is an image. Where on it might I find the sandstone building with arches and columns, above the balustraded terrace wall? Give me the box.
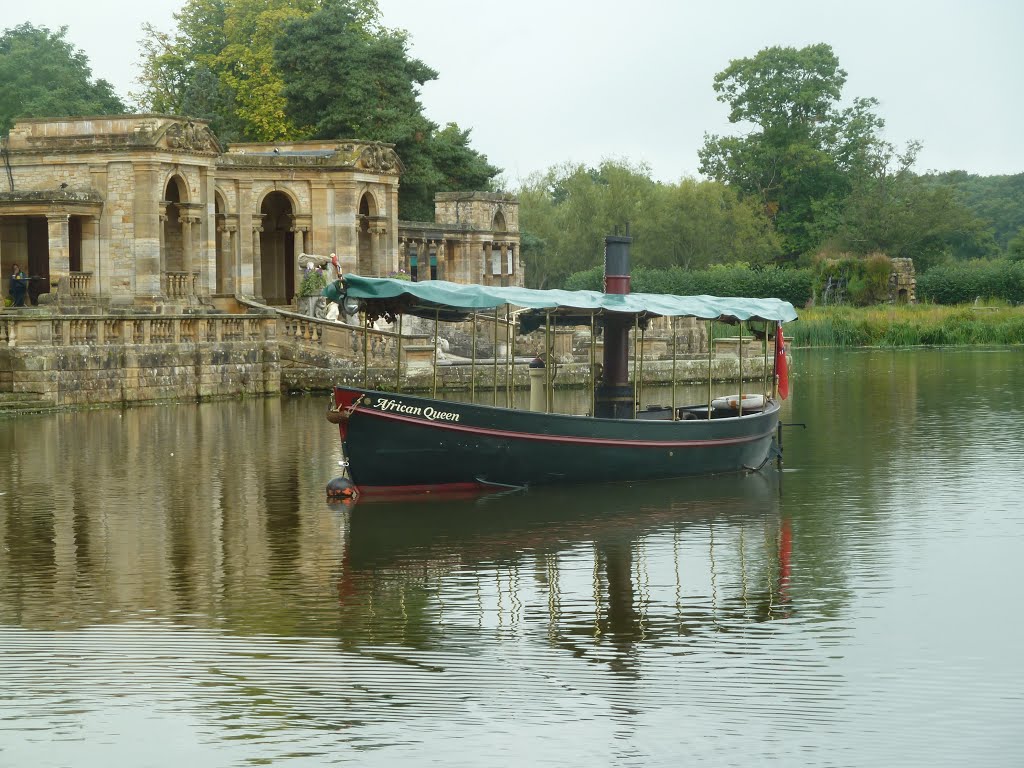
[0,115,522,313]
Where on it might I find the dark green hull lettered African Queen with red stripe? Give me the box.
[335,387,779,493]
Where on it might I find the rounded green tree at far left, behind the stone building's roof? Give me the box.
[0,24,128,131]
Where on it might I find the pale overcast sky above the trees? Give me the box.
[16,0,1024,186]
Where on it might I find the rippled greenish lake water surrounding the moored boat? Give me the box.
[0,348,1024,768]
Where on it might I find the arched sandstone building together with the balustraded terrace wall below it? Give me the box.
[0,115,523,404]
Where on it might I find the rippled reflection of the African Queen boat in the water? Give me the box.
[331,472,790,652]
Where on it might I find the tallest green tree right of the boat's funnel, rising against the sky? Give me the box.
[699,43,883,258]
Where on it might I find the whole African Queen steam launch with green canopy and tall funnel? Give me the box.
[325,238,797,493]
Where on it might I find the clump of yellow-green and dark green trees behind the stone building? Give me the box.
[136,0,499,219]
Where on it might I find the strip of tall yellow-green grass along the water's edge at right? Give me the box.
[785,304,1024,347]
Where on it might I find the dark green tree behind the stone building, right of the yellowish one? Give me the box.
[274,1,500,220]
